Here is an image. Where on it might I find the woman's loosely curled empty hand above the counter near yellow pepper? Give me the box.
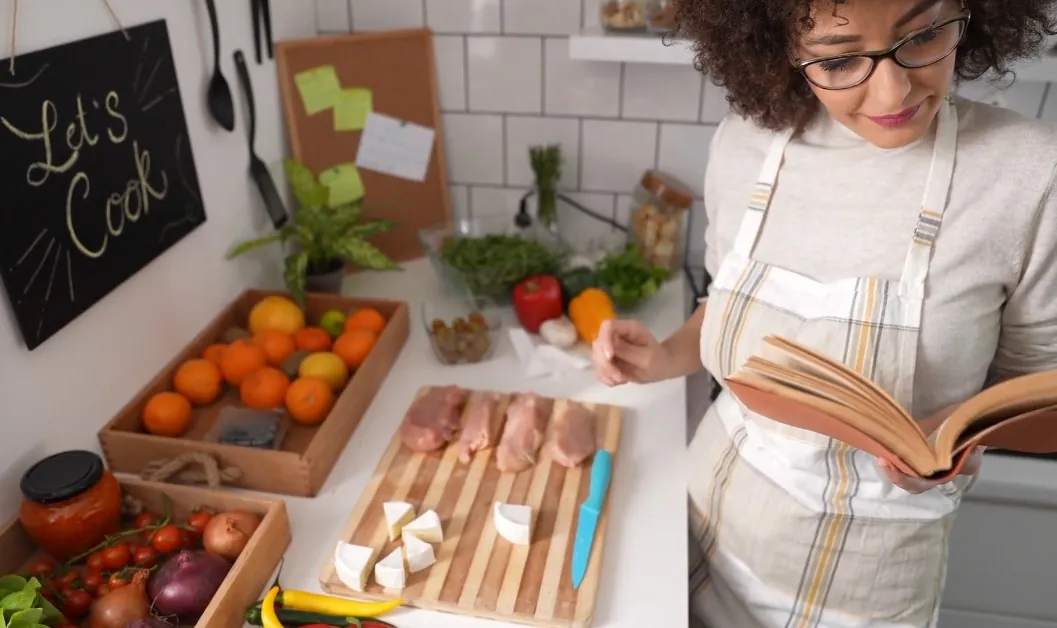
[591,320,670,386]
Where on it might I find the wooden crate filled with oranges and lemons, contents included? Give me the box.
[99,290,410,496]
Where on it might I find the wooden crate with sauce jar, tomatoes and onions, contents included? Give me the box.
[0,451,291,628]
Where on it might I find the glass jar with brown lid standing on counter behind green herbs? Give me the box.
[628,170,693,271]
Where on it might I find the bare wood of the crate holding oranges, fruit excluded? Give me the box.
[99,290,410,497]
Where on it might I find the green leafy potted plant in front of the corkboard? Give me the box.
[227,159,397,302]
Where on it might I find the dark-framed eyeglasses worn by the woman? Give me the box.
[795,11,969,90]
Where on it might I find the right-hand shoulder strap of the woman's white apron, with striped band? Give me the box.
[900,98,958,298]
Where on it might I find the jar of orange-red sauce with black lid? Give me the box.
[19,450,122,560]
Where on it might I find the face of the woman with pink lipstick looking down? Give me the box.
[796,0,963,148]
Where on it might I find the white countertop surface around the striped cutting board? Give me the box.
[247,259,688,628]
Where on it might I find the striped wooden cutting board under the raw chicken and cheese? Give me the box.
[319,387,622,628]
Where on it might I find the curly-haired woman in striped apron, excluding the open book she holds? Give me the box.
[594,0,1057,628]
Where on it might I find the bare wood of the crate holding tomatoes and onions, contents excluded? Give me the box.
[0,478,291,628]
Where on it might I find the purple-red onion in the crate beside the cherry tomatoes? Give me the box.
[147,550,231,622]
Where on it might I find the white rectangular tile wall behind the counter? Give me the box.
[315,0,1057,257]
